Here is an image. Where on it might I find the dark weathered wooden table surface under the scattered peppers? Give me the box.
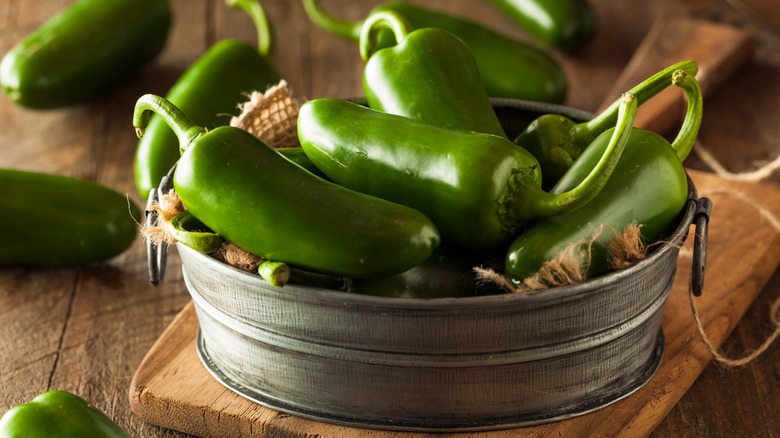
[0,0,780,437]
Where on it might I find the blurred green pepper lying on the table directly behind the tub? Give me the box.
[303,0,567,103]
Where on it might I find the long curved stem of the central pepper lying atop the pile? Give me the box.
[513,93,638,219]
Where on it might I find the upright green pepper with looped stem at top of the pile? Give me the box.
[360,11,506,137]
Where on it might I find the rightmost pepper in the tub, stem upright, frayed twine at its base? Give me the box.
[505,71,703,282]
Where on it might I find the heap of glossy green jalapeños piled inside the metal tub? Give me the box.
[146,6,701,297]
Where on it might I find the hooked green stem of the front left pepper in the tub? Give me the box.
[133,94,206,152]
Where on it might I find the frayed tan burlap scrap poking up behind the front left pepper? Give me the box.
[230,79,299,148]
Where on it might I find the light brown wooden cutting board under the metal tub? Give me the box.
[129,170,780,438]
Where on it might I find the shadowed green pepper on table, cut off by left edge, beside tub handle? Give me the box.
[0,169,141,266]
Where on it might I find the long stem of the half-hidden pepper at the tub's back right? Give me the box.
[572,60,699,143]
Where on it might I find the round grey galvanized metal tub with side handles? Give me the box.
[150,100,709,431]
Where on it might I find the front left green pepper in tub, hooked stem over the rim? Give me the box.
[133,95,440,277]
